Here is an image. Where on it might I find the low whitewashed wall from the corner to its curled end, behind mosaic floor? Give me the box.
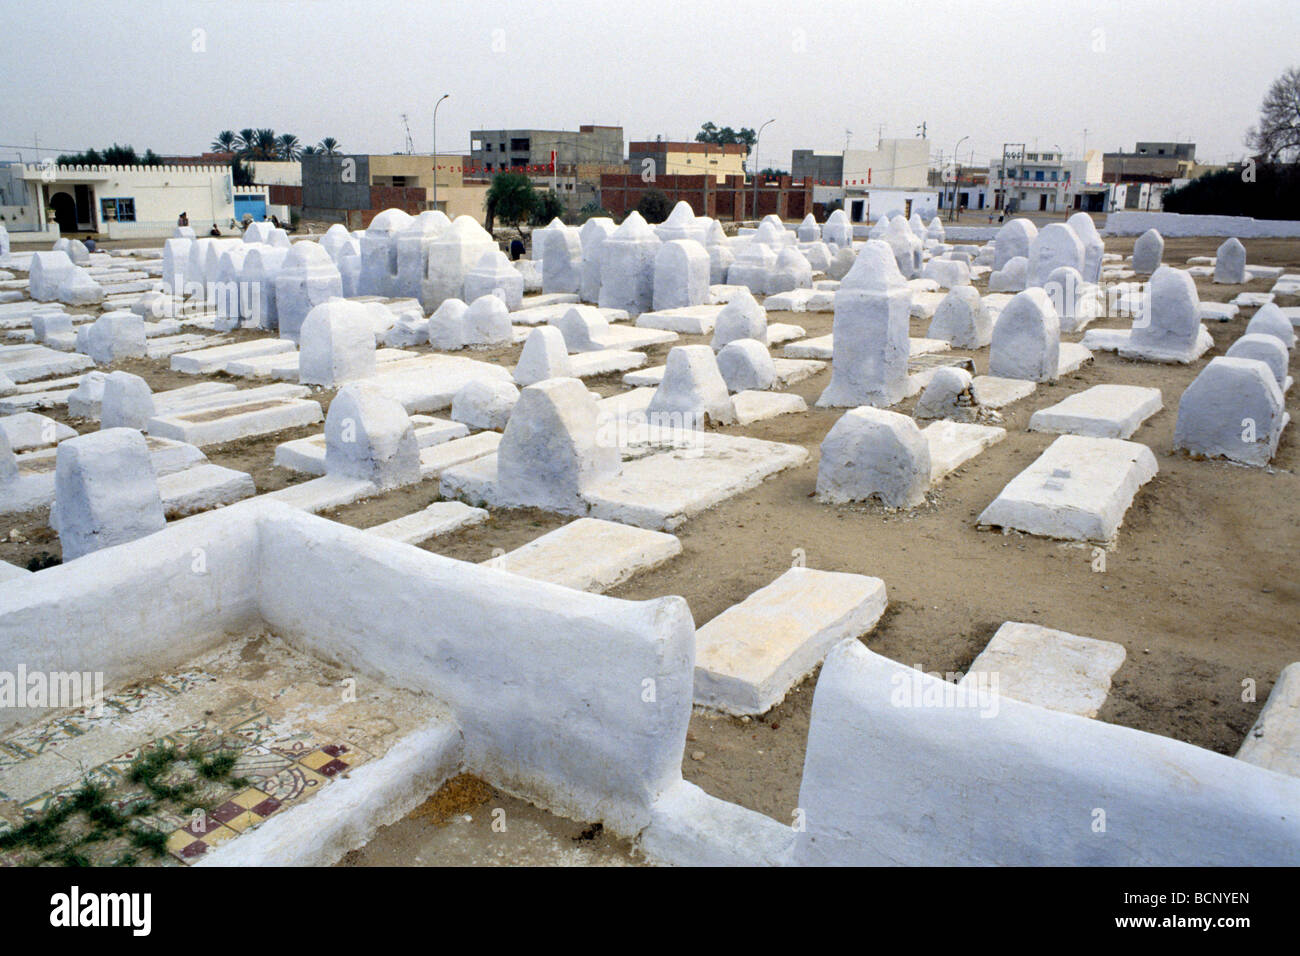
[257,509,694,835]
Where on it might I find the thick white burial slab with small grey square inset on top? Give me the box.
[976,434,1157,544]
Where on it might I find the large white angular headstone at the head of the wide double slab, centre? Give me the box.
[497,378,621,515]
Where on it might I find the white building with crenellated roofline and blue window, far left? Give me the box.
[0,163,235,239]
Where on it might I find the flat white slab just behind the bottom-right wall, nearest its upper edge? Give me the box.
[959,620,1126,717]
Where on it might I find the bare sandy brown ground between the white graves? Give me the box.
[0,230,1300,864]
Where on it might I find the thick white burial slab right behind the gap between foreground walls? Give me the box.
[694,567,888,715]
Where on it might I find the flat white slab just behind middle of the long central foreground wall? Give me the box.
[484,518,681,593]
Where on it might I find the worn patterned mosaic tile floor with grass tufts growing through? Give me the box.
[0,636,434,866]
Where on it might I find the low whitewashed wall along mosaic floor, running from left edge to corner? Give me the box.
[0,505,257,728]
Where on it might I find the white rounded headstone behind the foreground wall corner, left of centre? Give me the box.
[325,382,420,489]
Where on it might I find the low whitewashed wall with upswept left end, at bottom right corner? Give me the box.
[794,641,1300,866]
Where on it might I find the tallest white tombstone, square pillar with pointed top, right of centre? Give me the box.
[818,239,911,407]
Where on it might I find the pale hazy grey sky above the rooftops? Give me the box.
[0,0,1300,168]
